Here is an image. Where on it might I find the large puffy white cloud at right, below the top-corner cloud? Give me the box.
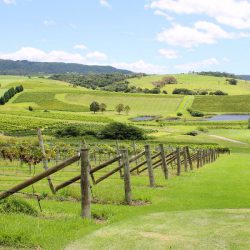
[157,21,243,48]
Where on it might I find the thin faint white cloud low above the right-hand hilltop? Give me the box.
[175,58,220,72]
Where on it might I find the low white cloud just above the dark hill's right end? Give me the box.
[112,60,167,74]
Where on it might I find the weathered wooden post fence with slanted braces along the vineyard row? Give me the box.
[0,144,227,218]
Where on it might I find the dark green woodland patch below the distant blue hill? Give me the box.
[50,73,143,91]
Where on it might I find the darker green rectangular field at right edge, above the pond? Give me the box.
[192,95,250,113]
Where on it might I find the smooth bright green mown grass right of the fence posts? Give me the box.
[66,154,250,250]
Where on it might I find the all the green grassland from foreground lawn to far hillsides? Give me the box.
[0,75,250,250]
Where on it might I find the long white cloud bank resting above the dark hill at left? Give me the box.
[0,47,107,64]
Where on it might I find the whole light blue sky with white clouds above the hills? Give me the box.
[0,0,250,74]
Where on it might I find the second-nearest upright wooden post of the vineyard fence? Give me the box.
[121,149,132,205]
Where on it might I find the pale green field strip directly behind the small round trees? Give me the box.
[57,91,183,116]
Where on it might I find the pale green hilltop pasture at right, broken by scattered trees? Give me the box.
[129,74,250,95]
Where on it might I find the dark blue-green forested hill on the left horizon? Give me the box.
[0,59,133,75]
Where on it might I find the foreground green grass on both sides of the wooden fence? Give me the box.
[0,153,250,249]
